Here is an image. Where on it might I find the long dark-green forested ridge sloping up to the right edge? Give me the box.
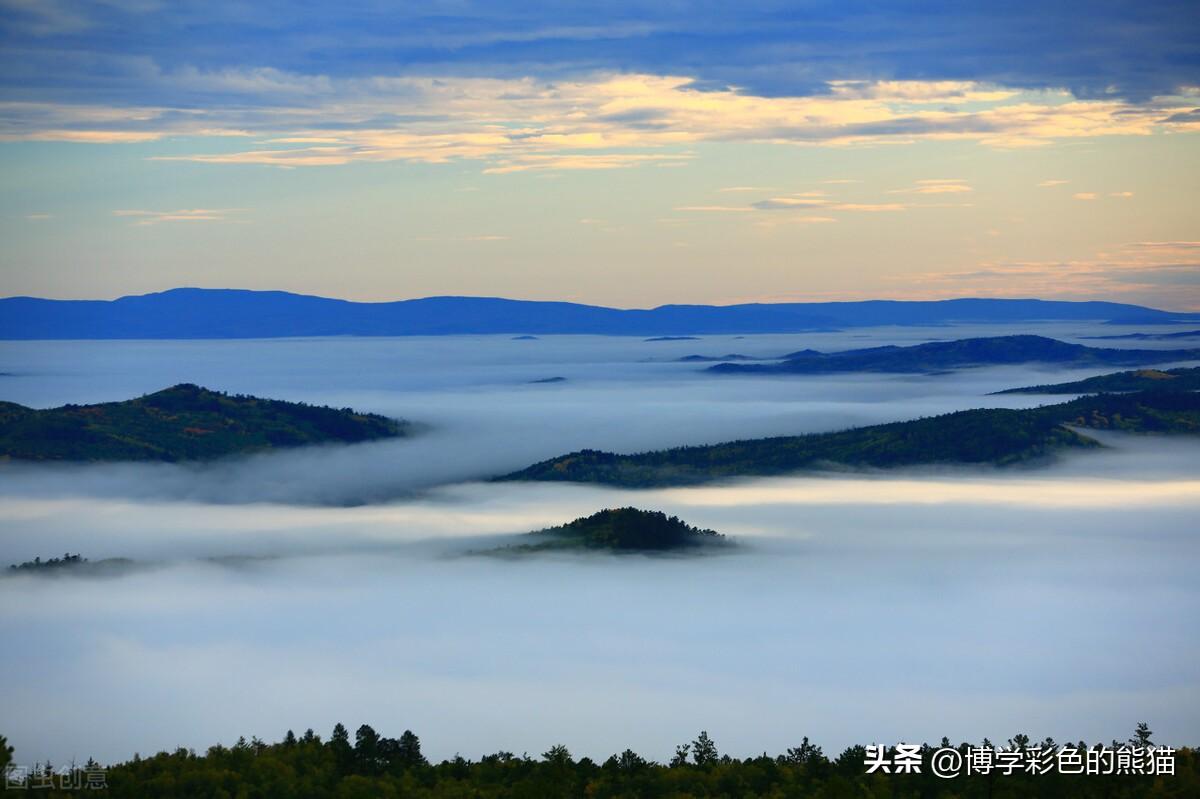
[499,392,1200,487]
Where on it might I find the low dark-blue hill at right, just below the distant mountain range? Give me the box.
[708,336,1200,374]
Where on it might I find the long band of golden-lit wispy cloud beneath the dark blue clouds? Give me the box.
[7,68,1200,171]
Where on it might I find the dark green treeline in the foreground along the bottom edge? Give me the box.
[0,725,1200,799]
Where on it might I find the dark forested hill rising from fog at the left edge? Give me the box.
[0,383,407,461]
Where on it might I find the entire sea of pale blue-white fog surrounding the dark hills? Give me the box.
[0,326,1200,763]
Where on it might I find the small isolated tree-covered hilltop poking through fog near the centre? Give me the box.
[480,507,727,554]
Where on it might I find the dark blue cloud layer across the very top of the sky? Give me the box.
[0,0,1200,106]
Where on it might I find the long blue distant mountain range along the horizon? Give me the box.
[0,288,1200,340]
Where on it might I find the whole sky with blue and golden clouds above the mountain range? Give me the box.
[0,0,1200,311]
